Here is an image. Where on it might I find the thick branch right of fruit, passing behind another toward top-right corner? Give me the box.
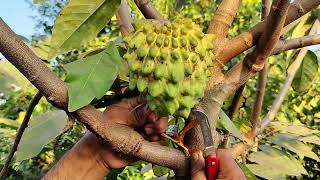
[219,0,320,63]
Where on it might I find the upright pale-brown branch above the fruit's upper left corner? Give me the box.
[116,0,134,36]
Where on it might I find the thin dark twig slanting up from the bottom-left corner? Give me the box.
[0,92,42,179]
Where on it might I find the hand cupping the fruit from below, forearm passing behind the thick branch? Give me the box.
[80,98,168,169]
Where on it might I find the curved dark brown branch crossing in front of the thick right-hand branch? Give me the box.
[225,0,289,92]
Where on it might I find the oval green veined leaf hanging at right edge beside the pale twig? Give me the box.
[292,51,319,93]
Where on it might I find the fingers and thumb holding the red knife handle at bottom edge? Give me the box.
[191,149,247,180]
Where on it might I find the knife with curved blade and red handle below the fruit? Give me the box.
[192,110,219,180]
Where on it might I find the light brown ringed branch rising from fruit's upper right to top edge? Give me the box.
[208,0,240,38]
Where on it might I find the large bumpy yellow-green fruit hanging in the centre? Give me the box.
[123,19,215,119]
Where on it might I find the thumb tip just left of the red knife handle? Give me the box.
[191,151,207,180]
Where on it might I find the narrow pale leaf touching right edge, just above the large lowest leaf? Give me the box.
[267,133,319,161]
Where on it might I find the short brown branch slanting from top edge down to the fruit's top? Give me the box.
[134,0,164,21]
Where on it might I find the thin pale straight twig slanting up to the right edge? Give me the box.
[253,20,319,136]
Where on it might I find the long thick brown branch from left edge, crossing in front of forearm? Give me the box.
[0,19,188,170]
